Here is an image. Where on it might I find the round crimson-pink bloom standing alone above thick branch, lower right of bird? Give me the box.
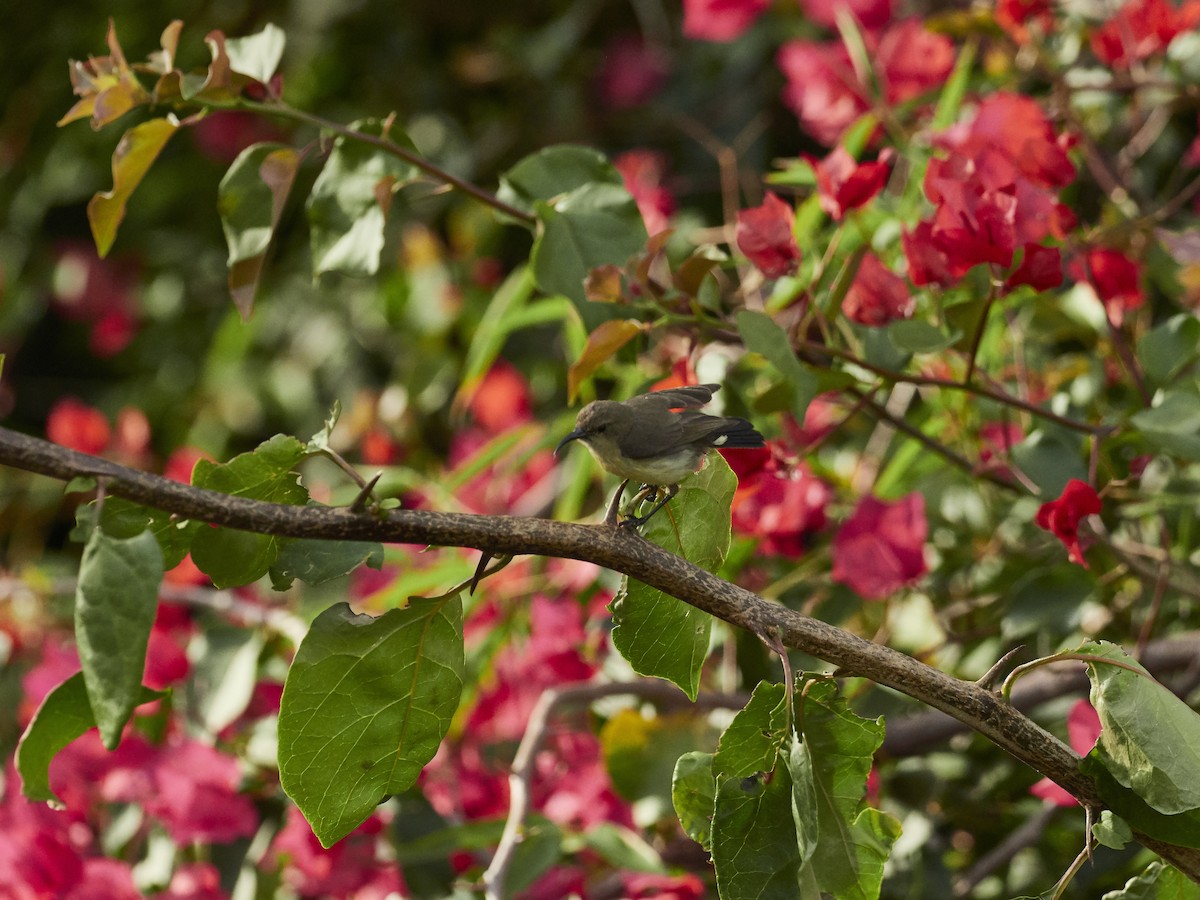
[833,493,929,600]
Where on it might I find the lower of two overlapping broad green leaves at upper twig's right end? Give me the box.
[529,182,647,309]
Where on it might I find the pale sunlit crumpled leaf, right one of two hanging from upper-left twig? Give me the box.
[307,119,420,276]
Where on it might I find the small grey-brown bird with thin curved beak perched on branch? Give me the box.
[554,384,763,528]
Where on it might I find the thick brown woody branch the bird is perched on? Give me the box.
[0,428,1200,880]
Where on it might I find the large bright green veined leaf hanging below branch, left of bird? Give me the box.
[278,595,463,847]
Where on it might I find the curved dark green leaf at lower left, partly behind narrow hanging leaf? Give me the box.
[17,672,166,803]
